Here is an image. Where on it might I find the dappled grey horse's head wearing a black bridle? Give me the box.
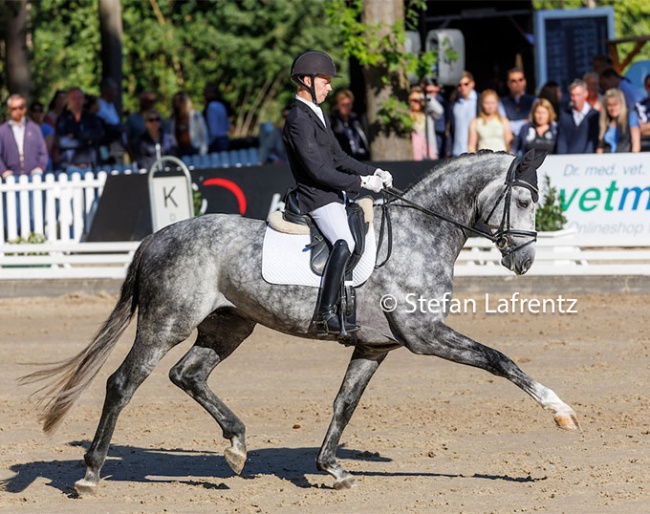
[477,150,546,275]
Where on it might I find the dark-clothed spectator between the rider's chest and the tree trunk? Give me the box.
[330,89,370,161]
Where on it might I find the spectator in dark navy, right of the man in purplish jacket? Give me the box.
[56,87,104,173]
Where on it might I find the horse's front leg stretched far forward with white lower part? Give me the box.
[405,321,580,430]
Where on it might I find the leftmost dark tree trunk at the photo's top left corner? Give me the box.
[5,0,32,101]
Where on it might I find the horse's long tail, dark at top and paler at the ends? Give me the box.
[19,237,151,433]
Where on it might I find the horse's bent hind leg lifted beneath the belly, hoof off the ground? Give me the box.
[169,313,255,474]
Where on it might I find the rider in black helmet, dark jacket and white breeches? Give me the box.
[282,50,393,336]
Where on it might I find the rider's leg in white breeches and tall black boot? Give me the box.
[309,203,359,335]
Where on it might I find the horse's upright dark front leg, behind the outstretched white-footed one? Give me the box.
[316,347,388,489]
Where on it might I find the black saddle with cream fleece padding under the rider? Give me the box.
[268,190,373,276]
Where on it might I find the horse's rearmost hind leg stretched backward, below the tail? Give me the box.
[75,330,187,494]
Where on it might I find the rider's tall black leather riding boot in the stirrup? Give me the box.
[315,239,359,336]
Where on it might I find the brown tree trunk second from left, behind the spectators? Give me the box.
[99,0,122,117]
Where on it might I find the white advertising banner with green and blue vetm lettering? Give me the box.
[539,153,650,244]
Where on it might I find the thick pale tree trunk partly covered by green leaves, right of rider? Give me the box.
[363,0,413,161]
